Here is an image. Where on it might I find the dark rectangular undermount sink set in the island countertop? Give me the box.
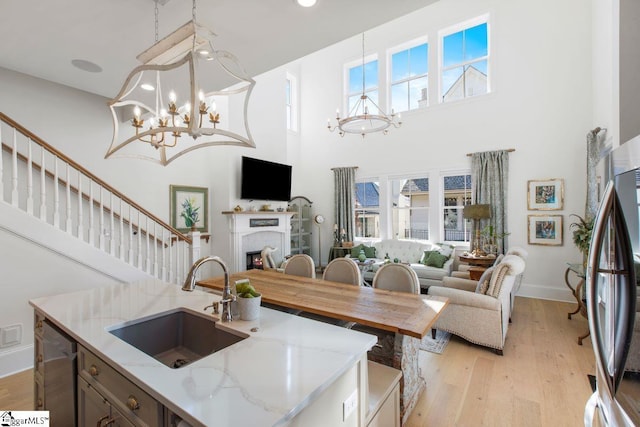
[109,309,247,368]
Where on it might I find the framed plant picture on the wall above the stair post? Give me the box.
[169,185,209,233]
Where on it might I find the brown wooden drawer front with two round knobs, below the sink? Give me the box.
[78,346,163,426]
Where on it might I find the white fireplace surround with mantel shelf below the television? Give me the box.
[222,211,295,273]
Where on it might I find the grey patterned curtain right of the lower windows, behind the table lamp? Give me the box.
[471,150,509,253]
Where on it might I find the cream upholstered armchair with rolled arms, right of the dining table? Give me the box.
[429,255,525,355]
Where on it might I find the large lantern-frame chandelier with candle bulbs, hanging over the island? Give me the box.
[105,0,255,166]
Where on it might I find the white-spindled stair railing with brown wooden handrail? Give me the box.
[0,113,199,283]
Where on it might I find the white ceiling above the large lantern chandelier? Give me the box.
[0,0,437,98]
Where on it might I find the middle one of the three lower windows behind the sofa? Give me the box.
[390,177,429,240]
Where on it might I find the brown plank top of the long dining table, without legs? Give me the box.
[197,269,448,338]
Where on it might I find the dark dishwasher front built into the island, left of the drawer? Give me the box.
[43,320,77,427]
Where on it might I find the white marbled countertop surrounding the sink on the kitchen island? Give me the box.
[30,280,376,427]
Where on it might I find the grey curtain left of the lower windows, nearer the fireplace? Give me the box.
[333,167,357,242]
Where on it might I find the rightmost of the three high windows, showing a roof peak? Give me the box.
[442,22,489,102]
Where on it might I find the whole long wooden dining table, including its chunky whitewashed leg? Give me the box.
[198,270,449,422]
